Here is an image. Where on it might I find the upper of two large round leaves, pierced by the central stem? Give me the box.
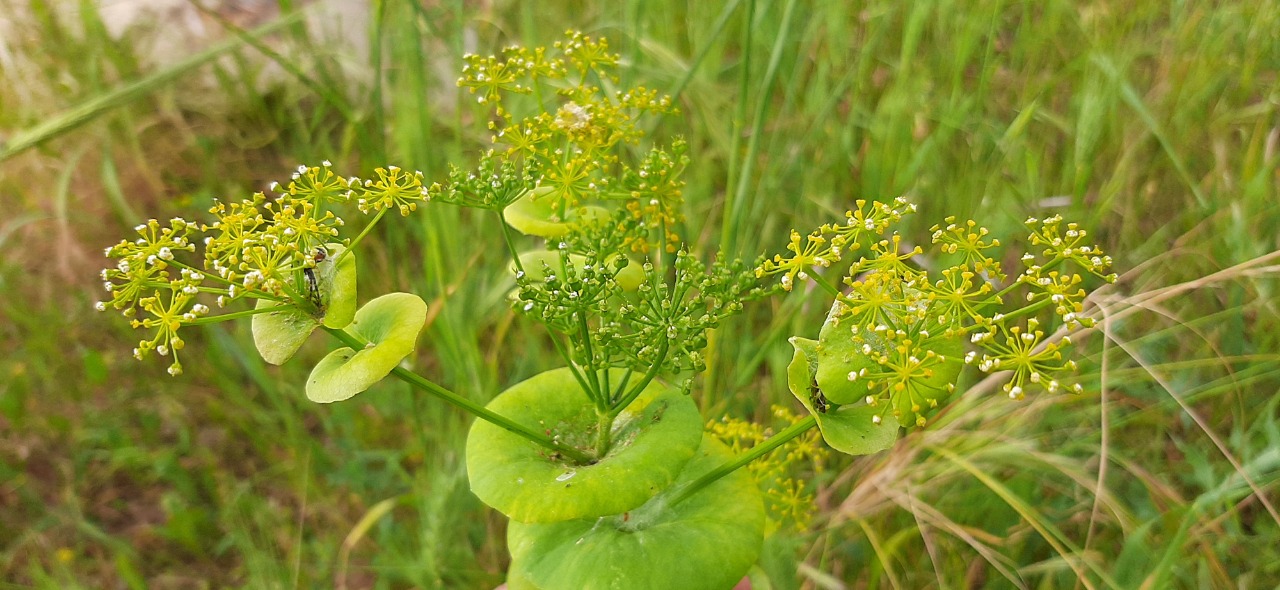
[467,369,703,522]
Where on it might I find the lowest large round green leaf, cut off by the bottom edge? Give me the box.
[507,436,764,590]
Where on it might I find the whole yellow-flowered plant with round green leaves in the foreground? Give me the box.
[82,27,1114,589]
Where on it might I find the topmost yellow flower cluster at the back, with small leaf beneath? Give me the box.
[426,31,689,252]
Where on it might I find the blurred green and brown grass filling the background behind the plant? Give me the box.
[0,0,1280,589]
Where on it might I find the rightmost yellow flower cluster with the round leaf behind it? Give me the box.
[756,198,1115,426]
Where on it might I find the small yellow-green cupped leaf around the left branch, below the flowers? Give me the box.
[307,293,426,403]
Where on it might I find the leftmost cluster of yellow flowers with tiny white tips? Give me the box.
[95,161,426,375]
